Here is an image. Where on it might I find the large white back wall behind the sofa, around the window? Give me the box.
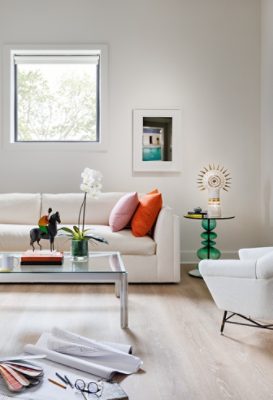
[0,0,260,261]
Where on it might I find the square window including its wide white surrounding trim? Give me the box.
[3,46,107,150]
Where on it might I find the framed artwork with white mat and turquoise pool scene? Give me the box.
[133,109,181,172]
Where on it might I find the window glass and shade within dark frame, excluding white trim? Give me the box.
[14,55,99,142]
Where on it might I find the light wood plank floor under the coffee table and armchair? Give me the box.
[0,267,273,400]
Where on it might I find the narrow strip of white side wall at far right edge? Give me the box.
[261,0,273,246]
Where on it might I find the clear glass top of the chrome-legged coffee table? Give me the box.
[0,252,126,274]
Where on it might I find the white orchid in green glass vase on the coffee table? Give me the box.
[59,168,108,261]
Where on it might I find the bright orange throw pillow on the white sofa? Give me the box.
[131,189,162,236]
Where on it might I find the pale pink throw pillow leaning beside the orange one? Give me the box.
[109,192,139,232]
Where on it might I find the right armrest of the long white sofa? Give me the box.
[153,207,180,282]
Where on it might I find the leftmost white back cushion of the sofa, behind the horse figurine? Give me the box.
[0,193,41,224]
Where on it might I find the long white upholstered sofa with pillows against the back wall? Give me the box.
[0,192,180,282]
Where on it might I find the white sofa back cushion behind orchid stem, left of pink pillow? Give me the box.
[42,192,124,225]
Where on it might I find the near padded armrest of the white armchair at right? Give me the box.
[199,260,256,279]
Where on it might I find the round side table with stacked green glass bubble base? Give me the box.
[184,215,235,278]
